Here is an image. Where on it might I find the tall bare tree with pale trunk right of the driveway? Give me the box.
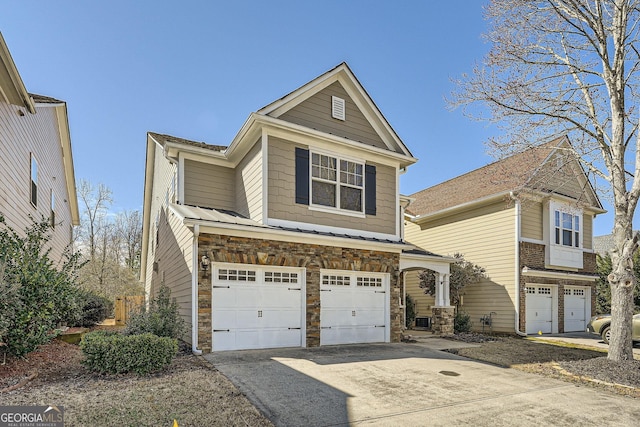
[451,0,640,361]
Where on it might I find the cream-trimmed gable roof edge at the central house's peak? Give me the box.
[256,62,413,157]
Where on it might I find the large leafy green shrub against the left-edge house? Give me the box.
[0,215,80,356]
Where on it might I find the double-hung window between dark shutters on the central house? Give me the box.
[311,153,364,212]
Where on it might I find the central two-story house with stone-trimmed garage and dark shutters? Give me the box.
[141,63,452,353]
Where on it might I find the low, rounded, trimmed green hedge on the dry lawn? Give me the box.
[80,331,178,375]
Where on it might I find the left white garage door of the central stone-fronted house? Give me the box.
[211,264,305,351]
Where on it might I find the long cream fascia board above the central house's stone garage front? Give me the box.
[183,218,409,253]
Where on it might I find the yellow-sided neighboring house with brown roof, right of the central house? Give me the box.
[405,136,605,334]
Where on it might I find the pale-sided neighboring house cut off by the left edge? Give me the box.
[0,34,80,262]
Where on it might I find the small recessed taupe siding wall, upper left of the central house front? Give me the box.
[184,160,235,210]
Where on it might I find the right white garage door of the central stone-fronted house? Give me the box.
[320,270,389,345]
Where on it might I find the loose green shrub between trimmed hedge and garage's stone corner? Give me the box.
[123,284,186,338]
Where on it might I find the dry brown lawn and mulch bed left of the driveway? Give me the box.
[0,340,272,427]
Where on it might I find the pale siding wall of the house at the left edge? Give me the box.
[0,102,76,262]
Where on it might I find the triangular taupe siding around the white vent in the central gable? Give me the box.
[279,82,387,149]
